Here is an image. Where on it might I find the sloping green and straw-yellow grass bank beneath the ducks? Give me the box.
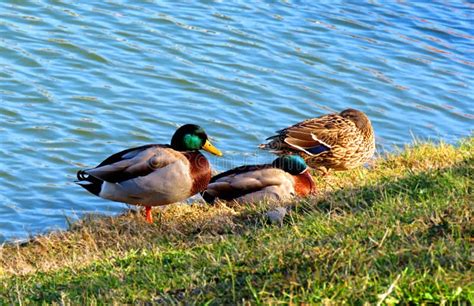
[0,138,474,304]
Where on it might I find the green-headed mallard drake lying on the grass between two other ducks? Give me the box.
[202,155,316,203]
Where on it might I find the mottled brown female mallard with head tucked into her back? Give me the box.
[260,109,375,174]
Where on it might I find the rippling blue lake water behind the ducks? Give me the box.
[0,0,474,241]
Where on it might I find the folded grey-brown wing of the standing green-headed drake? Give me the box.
[78,144,176,183]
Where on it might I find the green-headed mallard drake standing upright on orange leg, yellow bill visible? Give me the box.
[76,124,222,223]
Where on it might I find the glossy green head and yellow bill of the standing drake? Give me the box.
[171,124,222,156]
